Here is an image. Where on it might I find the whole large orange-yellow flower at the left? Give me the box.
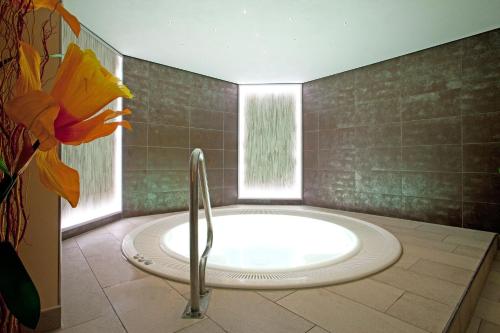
[6,42,132,207]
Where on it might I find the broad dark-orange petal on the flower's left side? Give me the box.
[5,90,59,151]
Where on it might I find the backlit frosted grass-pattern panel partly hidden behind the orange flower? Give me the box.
[61,22,123,230]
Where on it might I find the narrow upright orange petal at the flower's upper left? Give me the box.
[13,41,42,97]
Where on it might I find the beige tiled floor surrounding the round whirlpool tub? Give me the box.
[52,206,500,333]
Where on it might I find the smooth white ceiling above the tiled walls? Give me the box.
[64,0,500,83]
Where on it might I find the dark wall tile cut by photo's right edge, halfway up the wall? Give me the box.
[463,112,500,143]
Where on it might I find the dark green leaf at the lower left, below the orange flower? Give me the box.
[0,241,40,329]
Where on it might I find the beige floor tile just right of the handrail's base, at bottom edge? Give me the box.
[207,289,314,333]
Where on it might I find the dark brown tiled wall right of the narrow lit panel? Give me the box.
[303,29,500,232]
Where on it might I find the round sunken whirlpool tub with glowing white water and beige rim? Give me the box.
[122,207,401,289]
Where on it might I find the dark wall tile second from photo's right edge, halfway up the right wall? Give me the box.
[403,117,461,146]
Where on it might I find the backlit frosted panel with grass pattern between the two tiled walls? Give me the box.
[238,84,302,199]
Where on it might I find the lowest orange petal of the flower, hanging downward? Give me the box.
[36,146,80,208]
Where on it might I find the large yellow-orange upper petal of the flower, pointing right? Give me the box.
[52,44,132,121]
